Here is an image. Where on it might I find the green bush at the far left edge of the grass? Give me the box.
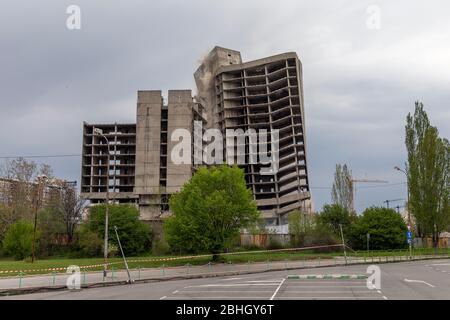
[3,220,39,260]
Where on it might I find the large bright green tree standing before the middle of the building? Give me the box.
[164,165,259,259]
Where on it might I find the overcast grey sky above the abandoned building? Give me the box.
[0,0,450,210]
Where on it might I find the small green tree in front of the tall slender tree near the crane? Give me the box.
[317,204,355,237]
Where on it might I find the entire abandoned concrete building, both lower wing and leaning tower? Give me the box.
[81,47,311,225]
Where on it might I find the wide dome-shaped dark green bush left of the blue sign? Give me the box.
[348,207,408,250]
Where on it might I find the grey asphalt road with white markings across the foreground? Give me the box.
[2,259,450,300]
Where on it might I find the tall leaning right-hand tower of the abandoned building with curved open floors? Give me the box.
[195,47,311,225]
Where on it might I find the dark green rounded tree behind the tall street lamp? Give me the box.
[87,204,152,256]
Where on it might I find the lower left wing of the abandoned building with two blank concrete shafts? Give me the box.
[81,90,205,221]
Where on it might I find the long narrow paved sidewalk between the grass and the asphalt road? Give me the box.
[0,255,448,294]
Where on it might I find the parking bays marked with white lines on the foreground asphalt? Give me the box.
[162,274,387,300]
